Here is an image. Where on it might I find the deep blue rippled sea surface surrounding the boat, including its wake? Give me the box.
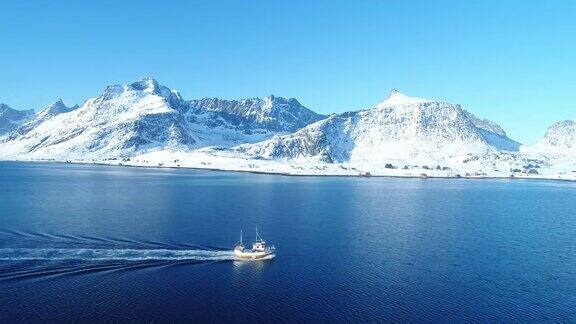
[0,163,576,323]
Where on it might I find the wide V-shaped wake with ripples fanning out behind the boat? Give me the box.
[0,231,273,281]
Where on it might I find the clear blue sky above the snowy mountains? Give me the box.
[0,0,576,143]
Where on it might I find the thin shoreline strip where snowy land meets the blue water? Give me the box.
[0,160,576,182]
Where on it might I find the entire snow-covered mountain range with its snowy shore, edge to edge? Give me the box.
[0,78,576,178]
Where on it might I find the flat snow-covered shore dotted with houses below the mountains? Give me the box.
[5,151,576,181]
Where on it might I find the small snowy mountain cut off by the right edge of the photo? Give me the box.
[522,120,576,158]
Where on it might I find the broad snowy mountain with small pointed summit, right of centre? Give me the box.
[239,90,519,163]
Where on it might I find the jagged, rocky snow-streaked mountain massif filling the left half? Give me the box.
[0,78,323,159]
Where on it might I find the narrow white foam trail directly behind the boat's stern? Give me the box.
[0,249,234,261]
